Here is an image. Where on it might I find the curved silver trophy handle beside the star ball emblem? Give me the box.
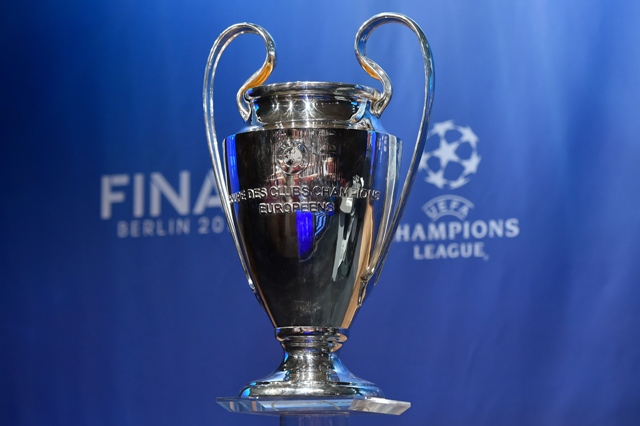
[355,13,435,286]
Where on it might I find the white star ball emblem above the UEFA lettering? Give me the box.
[418,120,481,189]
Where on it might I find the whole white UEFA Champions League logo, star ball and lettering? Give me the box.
[395,120,520,260]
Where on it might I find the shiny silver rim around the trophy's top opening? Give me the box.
[244,81,382,102]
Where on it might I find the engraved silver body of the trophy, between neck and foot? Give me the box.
[225,128,400,328]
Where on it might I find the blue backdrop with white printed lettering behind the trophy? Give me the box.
[0,0,640,425]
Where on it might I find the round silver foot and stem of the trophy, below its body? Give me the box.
[240,327,384,398]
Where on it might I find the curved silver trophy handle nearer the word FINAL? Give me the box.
[202,22,276,293]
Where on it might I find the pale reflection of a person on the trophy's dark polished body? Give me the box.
[332,175,364,281]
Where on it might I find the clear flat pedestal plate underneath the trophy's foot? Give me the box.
[217,397,411,426]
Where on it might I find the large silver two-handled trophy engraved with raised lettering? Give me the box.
[204,13,434,399]
